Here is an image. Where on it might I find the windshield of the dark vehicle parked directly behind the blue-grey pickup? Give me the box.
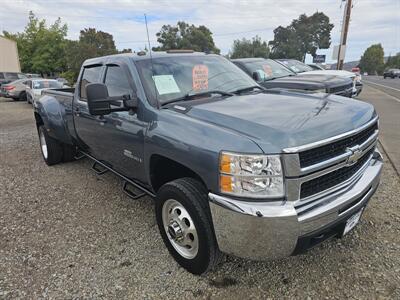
[245,59,295,80]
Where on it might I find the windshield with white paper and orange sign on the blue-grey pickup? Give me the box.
[137,54,255,104]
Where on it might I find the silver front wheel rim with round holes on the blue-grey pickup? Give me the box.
[162,199,199,259]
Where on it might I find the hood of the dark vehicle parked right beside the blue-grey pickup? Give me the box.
[261,74,351,90]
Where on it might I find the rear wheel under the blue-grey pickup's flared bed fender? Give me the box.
[38,125,63,166]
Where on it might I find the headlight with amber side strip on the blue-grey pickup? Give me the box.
[219,152,284,198]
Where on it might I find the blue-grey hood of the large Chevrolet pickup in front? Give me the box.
[186,92,375,153]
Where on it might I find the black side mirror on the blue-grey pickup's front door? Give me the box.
[86,83,111,116]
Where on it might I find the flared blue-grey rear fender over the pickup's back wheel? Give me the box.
[35,95,73,144]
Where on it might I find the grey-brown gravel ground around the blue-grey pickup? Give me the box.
[0,99,400,299]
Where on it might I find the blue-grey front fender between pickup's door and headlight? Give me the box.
[144,110,262,192]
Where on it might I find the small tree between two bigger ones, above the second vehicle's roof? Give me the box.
[230,36,269,58]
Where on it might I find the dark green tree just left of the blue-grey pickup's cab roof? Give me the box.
[63,28,118,83]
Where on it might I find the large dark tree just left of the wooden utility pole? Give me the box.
[269,12,334,61]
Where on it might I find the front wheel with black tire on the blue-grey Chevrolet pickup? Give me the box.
[156,178,223,275]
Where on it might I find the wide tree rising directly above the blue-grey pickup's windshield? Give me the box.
[153,22,220,53]
